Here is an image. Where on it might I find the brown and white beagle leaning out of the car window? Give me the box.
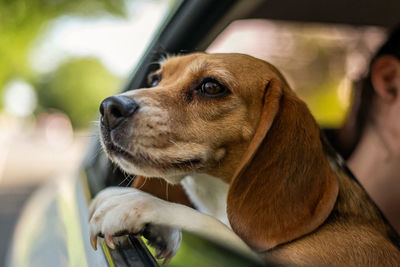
[90,53,400,266]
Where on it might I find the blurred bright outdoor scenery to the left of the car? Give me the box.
[0,0,174,266]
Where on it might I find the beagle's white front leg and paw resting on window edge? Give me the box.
[89,187,255,258]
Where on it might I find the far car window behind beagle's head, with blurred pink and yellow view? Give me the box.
[207,19,386,128]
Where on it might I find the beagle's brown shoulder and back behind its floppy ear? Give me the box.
[266,172,400,266]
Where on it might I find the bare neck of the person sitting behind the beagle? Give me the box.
[347,125,400,232]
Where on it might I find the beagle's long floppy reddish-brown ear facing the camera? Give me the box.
[227,79,338,252]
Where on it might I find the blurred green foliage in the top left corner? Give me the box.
[0,0,126,96]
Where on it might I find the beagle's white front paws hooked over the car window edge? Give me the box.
[89,187,182,262]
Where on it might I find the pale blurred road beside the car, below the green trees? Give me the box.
[0,114,90,267]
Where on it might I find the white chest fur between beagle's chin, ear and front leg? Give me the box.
[181,174,230,227]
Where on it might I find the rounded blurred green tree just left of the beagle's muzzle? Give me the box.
[36,58,119,128]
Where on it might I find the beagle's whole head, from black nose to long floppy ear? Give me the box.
[101,53,338,251]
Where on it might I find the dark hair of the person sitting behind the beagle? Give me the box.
[334,25,400,159]
